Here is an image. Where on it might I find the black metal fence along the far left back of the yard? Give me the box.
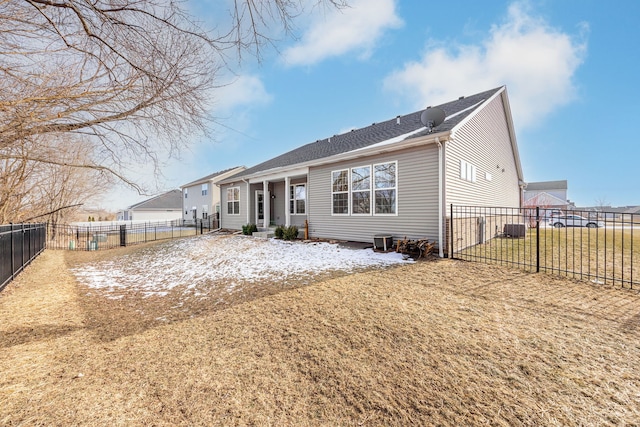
[46,217,218,251]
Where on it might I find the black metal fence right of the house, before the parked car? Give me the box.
[447,205,640,289]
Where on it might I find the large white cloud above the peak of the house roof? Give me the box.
[384,3,587,127]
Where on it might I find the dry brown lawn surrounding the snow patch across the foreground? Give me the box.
[0,242,640,426]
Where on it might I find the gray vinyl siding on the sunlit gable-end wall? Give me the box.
[445,96,520,207]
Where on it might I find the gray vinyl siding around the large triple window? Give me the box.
[307,145,438,242]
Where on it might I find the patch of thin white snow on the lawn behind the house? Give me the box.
[73,235,412,298]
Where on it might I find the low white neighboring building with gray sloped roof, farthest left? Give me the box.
[118,190,182,221]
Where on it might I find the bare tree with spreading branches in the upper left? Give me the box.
[0,0,345,224]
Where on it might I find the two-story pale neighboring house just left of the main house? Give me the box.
[181,166,246,221]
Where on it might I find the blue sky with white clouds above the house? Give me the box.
[107,0,640,209]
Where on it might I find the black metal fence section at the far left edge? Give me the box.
[0,223,47,291]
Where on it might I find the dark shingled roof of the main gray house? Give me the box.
[227,87,503,180]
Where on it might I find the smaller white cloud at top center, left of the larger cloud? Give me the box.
[283,0,402,65]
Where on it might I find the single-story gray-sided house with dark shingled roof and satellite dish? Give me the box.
[220,86,524,256]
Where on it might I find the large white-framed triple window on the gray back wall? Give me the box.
[331,162,398,219]
